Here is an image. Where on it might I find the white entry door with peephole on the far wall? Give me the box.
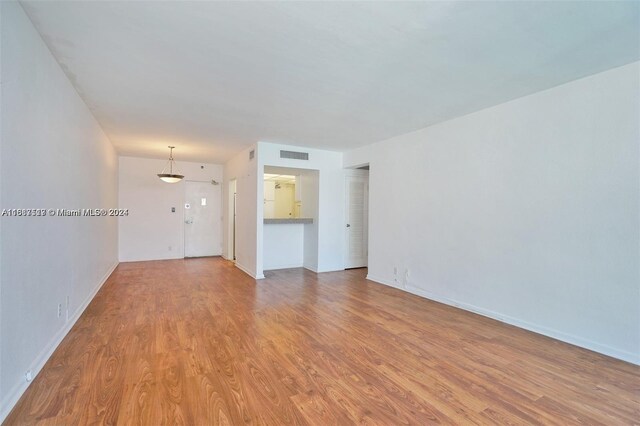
[184,182,222,257]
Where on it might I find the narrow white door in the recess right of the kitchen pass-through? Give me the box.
[345,170,369,268]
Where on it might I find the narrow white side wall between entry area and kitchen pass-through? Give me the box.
[223,145,264,278]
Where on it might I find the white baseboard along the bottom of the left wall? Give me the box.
[0,262,119,424]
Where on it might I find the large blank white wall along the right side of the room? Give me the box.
[345,63,640,363]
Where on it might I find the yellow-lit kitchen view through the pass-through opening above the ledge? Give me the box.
[264,173,302,219]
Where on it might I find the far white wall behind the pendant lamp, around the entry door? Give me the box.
[118,156,223,262]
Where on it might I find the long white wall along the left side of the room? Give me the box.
[0,2,118,421]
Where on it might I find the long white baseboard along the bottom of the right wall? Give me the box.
[367,275,640,365]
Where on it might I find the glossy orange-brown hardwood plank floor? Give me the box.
[5,258,640,425]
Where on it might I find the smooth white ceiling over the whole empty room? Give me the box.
[22,1,640,162]
